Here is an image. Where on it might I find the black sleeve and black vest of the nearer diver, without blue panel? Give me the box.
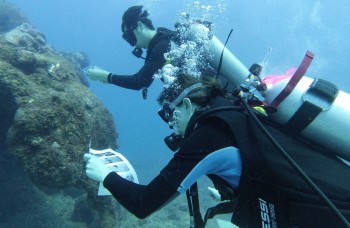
[104,95,350,228]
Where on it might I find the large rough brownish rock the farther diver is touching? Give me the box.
[0,2,117,227]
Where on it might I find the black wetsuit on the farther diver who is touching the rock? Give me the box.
[108,28,177,90]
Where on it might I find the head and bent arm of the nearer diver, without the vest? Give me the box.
[84,74,241,224]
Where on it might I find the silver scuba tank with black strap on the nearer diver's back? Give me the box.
[263,52,350,160]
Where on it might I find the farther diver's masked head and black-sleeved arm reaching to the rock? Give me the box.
[87,6,177,98]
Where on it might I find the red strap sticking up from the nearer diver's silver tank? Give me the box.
[270,51,314,108]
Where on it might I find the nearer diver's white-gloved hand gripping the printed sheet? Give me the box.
[84,154,112,182]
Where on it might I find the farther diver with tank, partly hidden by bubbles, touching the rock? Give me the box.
[86,6,232,99]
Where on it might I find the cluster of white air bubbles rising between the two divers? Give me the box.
[156,0,224,90]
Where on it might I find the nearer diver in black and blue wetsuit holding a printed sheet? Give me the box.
[84,73,350,227]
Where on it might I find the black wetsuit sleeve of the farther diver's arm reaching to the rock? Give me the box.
[108,39,170,90]
